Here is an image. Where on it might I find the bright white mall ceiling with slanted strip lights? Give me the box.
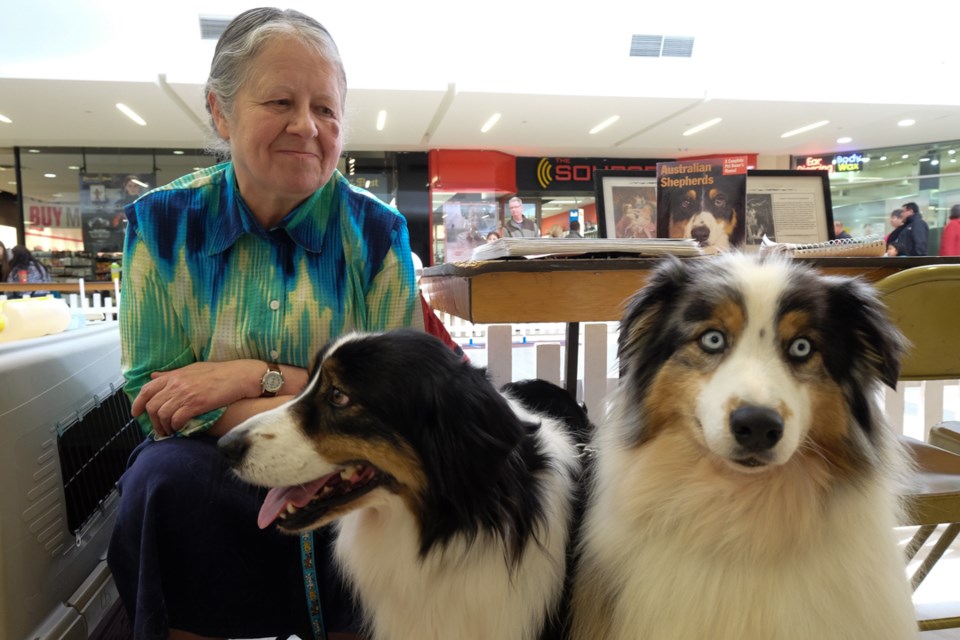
[0,0,960,192]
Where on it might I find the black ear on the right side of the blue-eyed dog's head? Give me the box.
[827,278,907,389]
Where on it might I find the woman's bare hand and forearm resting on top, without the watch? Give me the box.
[131,360,266,437]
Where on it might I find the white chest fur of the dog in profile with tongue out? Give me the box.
[336,430,572,640]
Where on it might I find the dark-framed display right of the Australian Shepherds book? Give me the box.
[745,170,834,249]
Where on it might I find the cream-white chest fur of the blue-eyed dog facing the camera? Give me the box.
[577,436,917,640]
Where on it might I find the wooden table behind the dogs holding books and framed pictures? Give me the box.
[420,257,960,391]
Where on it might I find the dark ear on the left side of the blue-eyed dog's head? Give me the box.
[617,256,691,386]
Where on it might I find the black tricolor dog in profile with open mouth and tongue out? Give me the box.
[220,331,589,640]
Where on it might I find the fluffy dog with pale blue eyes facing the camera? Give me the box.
[573,254,917,640]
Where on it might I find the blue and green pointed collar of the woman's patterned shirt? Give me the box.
[209,163,345,255]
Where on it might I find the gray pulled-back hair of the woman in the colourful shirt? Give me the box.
[203,7,347,157]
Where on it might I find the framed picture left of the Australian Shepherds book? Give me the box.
[593,169,657,238]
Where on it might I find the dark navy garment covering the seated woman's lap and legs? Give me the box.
[107,436,354,640]
